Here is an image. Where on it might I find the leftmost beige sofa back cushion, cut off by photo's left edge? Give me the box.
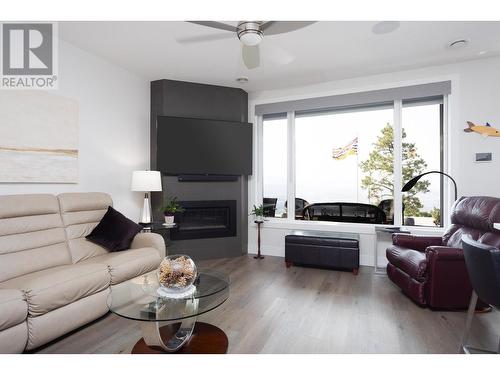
[0,194,71,282]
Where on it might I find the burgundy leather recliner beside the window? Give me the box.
[386,197,500,310]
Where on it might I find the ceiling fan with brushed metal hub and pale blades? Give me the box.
[177,21,315,69]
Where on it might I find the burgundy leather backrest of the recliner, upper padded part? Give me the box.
[443,196,500,247]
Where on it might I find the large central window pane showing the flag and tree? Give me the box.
[295,107,394,224]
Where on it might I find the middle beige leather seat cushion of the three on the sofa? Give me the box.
[0,264,110,317]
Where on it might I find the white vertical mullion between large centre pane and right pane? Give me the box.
[393,100,403,226]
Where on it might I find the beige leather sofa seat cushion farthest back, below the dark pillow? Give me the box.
[78,247,161,285]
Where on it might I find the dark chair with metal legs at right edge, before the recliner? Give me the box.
[459,236,500,354]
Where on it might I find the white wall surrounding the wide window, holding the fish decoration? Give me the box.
[248,57,500,265]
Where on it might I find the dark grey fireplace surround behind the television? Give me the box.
[150,79,248,260]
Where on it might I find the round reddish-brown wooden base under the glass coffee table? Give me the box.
[132,319,228,354]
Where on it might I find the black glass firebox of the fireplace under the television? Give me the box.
[171,200,236,241]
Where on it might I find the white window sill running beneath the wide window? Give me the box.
[250,218,445,235]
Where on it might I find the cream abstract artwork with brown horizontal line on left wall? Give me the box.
[0,90,78,183]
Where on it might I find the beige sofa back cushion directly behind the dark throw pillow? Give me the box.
[57,193,113,263]
